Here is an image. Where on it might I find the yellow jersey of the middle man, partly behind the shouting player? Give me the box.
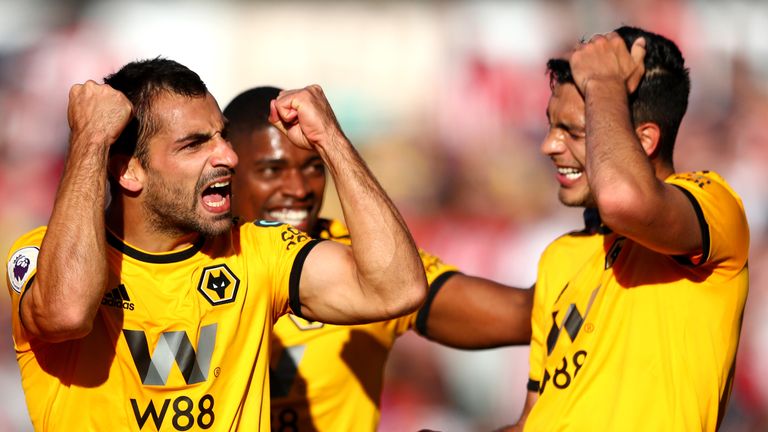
[271,220,456,432]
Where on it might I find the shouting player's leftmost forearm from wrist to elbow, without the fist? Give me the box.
[22,137,108,341]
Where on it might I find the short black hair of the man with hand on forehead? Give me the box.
[547,26,691,162]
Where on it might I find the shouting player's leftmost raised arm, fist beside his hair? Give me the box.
[20,81,132,342]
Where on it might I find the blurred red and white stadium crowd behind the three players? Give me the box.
[0,0,768,431]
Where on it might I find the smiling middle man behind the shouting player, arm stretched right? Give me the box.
[224,87,533,431]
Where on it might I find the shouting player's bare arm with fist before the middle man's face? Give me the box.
[270,86,427,324]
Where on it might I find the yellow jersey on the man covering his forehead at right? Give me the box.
[525,172,749,431]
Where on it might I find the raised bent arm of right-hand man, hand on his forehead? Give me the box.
[570,33,702,255]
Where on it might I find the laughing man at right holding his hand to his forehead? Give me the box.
[504,27,749,431]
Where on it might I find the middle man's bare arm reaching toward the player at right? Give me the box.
[419,273,533,349]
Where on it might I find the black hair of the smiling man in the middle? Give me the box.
[224,86,282,137]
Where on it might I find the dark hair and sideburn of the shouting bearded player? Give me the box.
[104,57,208,166]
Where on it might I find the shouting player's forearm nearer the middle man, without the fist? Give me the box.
[318,136,426,315]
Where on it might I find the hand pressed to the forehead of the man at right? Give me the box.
[569,32,645,95]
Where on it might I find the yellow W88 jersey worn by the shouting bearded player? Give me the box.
[6,222,317,431]
